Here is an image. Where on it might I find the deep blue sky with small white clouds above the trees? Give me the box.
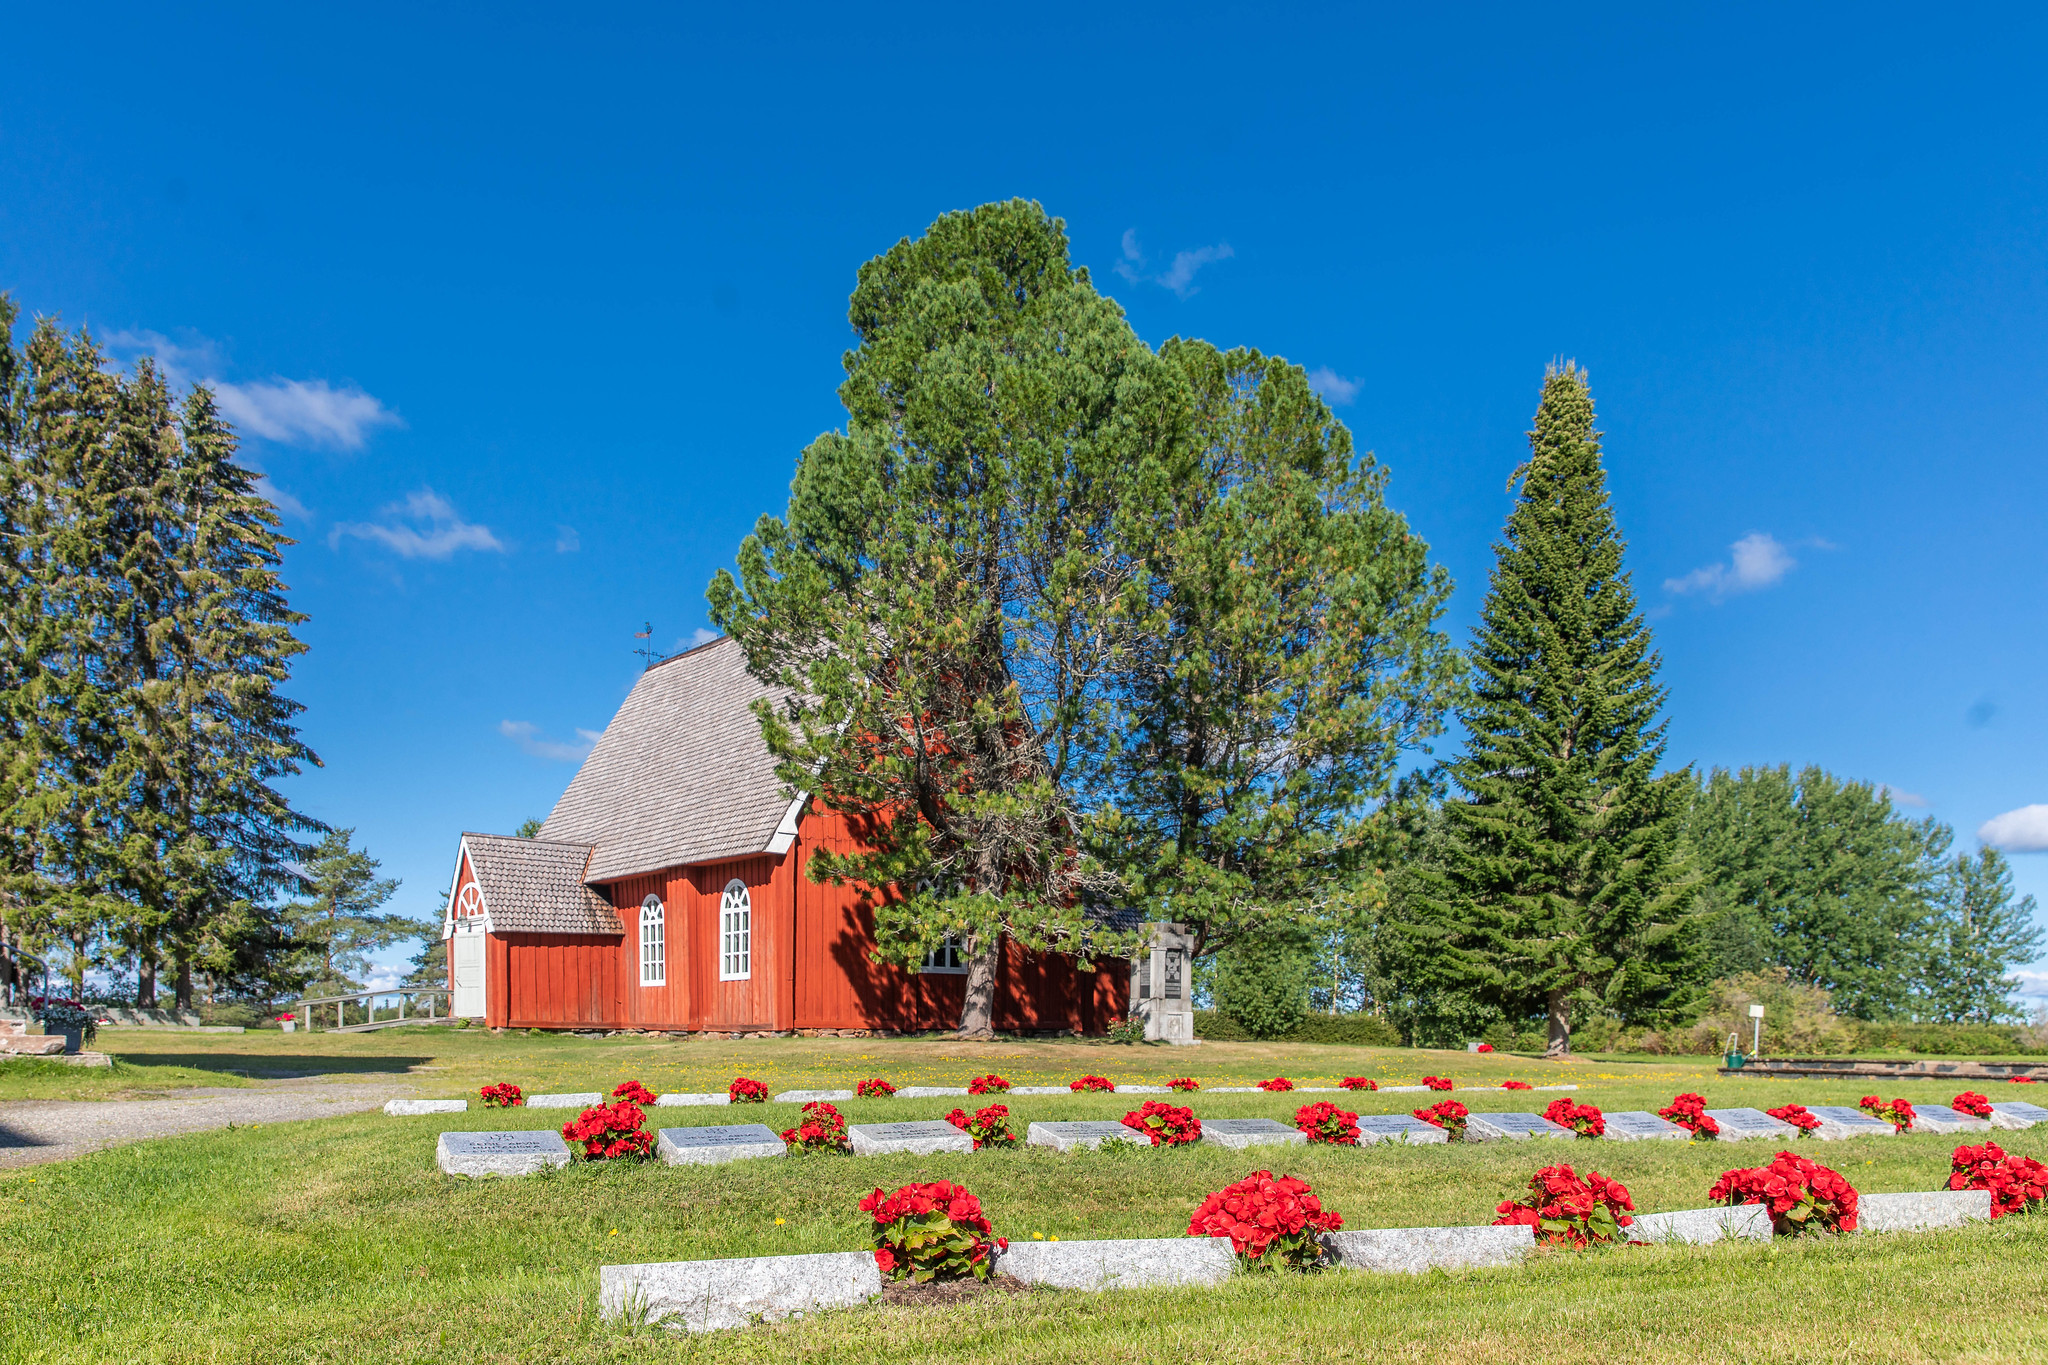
[0,4,2048,990]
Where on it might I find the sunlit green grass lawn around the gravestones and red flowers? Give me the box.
[0,1029,2048,1365]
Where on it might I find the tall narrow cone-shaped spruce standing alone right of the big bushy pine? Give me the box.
[1440,364,1694,1054]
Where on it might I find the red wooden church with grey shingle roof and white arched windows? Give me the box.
[442,639,1130,1033]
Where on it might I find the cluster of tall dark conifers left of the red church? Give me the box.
[0,297,420,1007]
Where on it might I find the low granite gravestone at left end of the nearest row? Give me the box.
[598,1250,883,1332]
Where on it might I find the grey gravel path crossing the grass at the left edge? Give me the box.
[0,1083,410,1169]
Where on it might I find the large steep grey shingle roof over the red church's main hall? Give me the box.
[541,639,791,882]
